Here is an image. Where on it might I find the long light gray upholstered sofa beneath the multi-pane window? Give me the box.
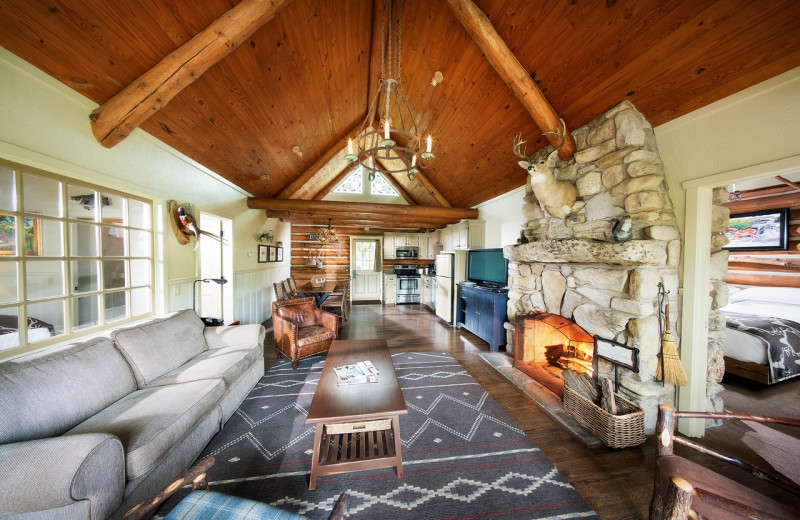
[0,310,265,520]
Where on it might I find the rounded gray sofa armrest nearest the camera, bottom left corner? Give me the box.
[0,433,125,518]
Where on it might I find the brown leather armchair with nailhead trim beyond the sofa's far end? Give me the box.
[272,298,339,368]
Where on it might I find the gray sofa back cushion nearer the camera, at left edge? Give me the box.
[0,338,136,443]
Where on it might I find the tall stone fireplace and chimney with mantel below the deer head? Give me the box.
[504,101,692,433]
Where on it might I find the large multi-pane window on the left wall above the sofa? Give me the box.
[0,163,154,356]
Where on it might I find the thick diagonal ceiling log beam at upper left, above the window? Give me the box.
[89,0,292,148]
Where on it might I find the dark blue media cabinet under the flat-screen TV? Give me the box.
[456,283,508,352]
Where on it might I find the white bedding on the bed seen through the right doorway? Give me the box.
[721,287,800,365]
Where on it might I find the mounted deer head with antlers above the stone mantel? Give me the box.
[514,119,583,218]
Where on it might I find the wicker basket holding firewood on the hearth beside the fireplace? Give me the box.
[564,386,645,448]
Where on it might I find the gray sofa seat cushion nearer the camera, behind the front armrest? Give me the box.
[67,379,225,480]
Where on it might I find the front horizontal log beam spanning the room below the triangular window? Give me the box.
[247,197,478,219]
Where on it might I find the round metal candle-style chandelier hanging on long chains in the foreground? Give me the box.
[345,0,434,180]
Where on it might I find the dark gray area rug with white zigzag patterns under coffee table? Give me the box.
[158,352,599,520]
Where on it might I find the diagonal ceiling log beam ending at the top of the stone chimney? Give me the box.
[445,0,575,160]
